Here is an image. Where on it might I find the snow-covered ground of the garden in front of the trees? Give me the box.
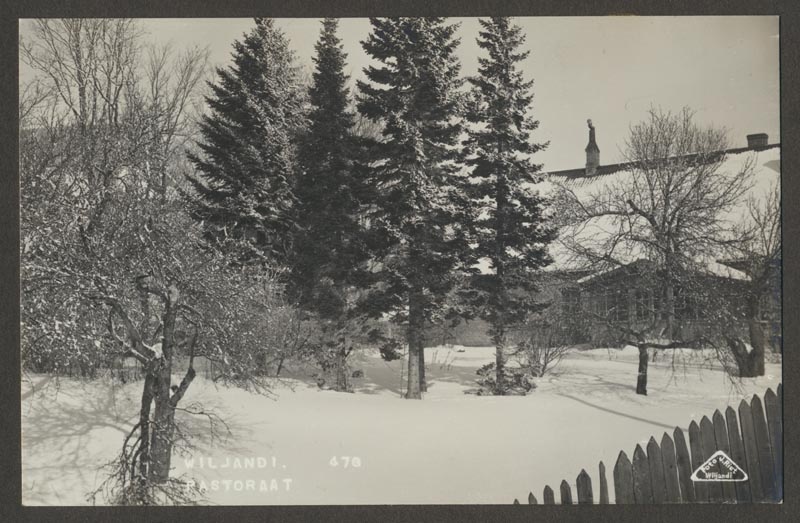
[22,347,781,505]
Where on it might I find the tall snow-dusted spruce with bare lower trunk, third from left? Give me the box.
[358,18,466,399]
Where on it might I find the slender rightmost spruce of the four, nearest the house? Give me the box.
[464,17,554,395]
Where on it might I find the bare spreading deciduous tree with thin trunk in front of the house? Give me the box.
[558,108,753,394]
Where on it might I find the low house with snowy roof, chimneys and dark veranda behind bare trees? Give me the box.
[546,120,781,350]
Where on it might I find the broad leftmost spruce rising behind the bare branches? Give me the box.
[188,18,303,259]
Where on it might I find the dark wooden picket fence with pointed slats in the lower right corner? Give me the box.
[514,385,783,505]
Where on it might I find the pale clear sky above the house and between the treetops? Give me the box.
[20,16,780,171]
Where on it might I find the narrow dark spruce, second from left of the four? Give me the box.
[291,18,365,390]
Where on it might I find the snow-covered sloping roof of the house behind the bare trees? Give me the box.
[536,144,780,279]
